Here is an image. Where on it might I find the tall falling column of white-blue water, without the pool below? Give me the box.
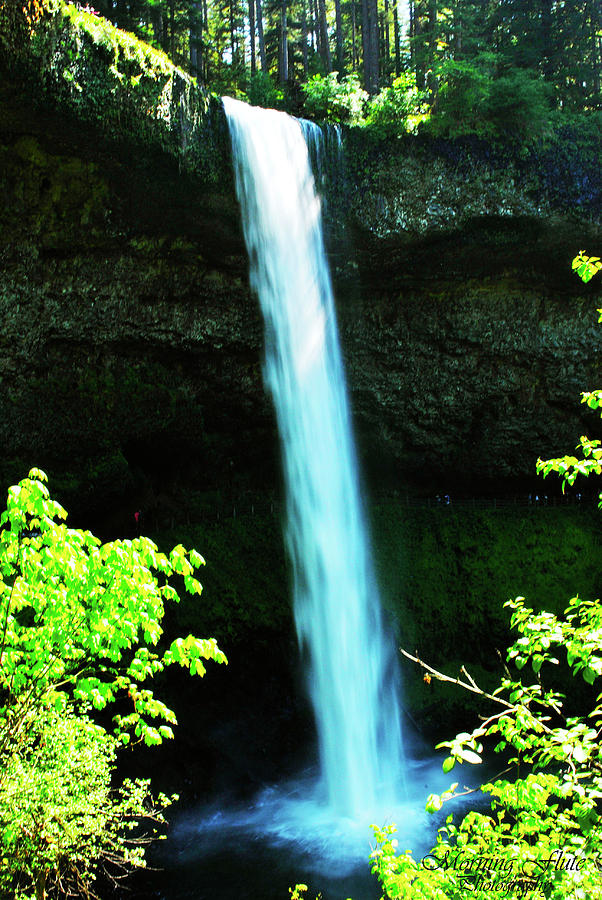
[224,98,403,819]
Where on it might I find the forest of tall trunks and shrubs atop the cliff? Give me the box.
[86,0,602,133]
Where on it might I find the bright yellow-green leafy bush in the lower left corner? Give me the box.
[0,469,226,897]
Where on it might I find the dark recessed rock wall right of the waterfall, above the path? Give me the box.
[341,210,602,491]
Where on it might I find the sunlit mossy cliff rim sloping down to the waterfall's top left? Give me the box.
[0,0,222,181]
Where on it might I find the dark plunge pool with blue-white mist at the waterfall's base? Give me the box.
[136,759,482,900]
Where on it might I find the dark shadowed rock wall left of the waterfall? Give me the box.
[0,96,274,508]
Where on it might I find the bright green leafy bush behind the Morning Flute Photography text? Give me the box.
[372,597,602,900]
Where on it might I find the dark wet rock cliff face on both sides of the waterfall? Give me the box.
[0,76,602,507]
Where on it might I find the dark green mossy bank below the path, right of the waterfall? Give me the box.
[372,500,600,724]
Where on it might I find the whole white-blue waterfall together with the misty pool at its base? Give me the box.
[141,98,460,900]
